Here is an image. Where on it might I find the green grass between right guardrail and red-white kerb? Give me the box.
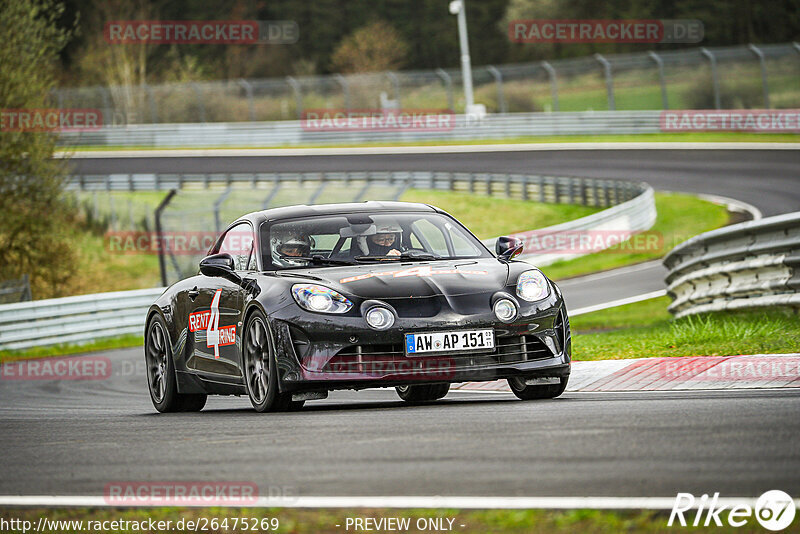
[570,297,800,360]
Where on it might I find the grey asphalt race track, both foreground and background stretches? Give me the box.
[0,146,800,497]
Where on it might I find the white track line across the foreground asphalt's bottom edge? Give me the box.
[0,495,800,510]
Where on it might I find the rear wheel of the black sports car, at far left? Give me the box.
[144,315,207,413]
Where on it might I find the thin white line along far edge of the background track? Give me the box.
[55,142,800,158]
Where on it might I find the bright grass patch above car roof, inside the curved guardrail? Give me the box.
[400,190,600,239]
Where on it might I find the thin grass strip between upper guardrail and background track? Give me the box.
[61,132,800,152]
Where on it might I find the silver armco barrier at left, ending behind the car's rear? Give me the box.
[0,287,164,350]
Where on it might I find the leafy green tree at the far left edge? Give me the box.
[0,0,75,298]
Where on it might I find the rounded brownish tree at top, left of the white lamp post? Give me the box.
[331,20,408,72]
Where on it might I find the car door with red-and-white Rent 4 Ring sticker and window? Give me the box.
[188,222,254,381]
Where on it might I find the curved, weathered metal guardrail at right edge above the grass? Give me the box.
[664,212,800,317]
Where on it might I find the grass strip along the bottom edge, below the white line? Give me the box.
[0,508,763,534]
